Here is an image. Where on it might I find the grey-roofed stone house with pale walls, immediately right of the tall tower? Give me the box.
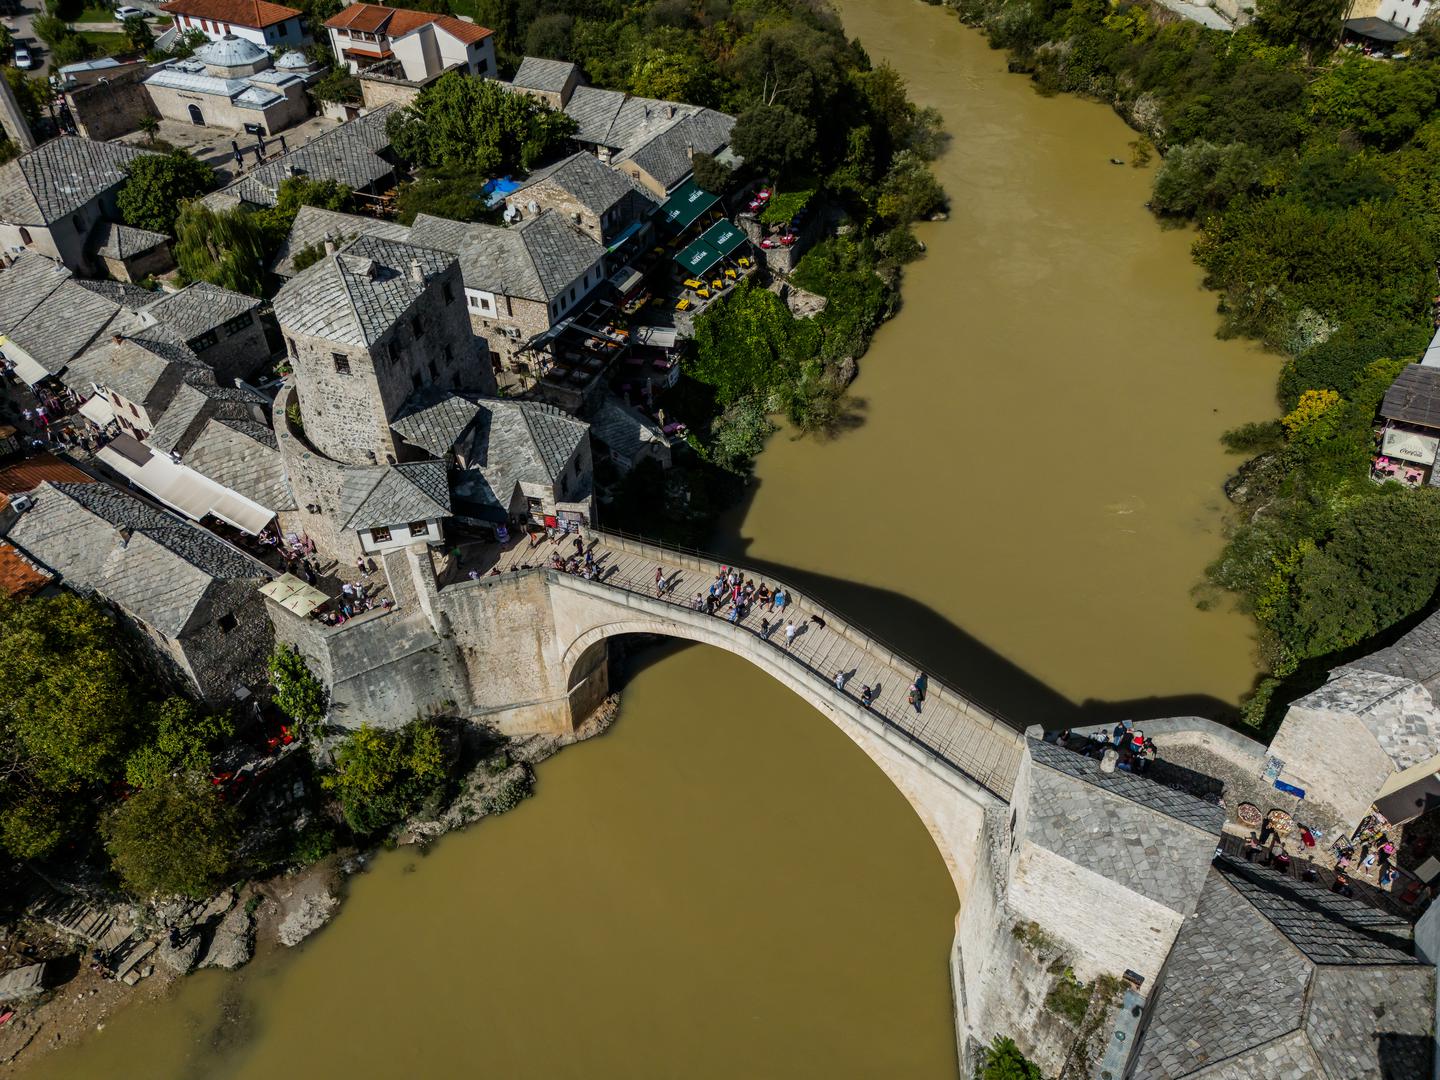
[410,210,605,360]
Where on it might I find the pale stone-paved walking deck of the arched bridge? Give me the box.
[467,528,1024,801]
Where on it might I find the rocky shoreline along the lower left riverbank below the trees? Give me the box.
[0,694,619,1074]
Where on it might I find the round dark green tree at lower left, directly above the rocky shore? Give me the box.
[101,776,238,899]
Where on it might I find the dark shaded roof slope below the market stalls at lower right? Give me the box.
[1215,855,1418,965]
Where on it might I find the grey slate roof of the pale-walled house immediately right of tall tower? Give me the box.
[410,210,605,302]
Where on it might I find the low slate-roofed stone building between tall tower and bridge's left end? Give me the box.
[393,387,593,526]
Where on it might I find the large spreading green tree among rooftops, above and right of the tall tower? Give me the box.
[389,72,576,177]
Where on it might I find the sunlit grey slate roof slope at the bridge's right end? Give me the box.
[1025,768,1218,913]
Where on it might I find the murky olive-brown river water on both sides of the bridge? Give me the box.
[29,0,1274,1080]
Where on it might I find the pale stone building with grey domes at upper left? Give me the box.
[145,35,310,135]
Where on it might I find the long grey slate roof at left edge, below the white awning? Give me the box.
[10,484,268,638]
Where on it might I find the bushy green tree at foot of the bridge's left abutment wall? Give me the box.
[321,720,445,835]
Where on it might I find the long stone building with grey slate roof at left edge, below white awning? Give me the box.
[7,481,272,701]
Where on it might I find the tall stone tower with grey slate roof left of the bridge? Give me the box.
[275,236,495,465]
